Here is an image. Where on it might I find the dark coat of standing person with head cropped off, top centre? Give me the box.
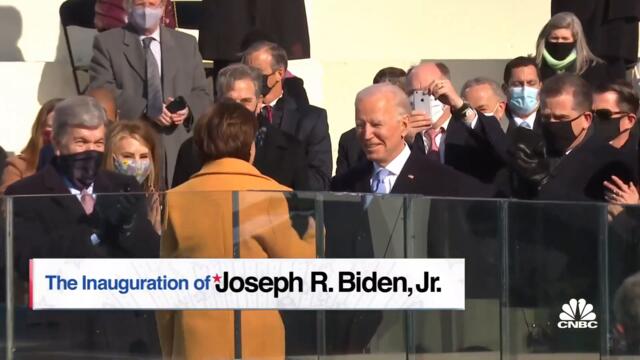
[199,0,310,61]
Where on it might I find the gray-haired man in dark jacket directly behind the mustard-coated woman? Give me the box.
[173,64,308,190]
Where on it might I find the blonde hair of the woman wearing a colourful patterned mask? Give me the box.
[104,120,163,192]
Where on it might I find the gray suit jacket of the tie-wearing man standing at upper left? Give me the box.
[89,26,211,185]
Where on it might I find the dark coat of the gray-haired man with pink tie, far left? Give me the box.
[5,165,160,358]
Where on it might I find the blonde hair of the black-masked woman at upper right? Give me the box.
[536,12,603,75]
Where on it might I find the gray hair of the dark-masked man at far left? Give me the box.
[52,96,107,144]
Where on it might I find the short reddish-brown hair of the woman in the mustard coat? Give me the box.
[193,100,258,163]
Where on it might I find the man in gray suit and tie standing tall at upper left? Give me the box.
[89,0,211,185]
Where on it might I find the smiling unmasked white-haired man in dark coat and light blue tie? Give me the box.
[331,82,495,197]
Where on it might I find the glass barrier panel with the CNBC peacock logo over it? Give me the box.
[503,201,607,359]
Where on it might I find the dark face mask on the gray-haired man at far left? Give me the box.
[54,150,102,190]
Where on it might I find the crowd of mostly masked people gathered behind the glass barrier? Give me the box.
[0,0,640,358]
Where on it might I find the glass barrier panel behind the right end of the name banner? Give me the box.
[407,197,503,359]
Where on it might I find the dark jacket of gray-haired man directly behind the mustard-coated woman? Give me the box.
[172,125,309,190]
